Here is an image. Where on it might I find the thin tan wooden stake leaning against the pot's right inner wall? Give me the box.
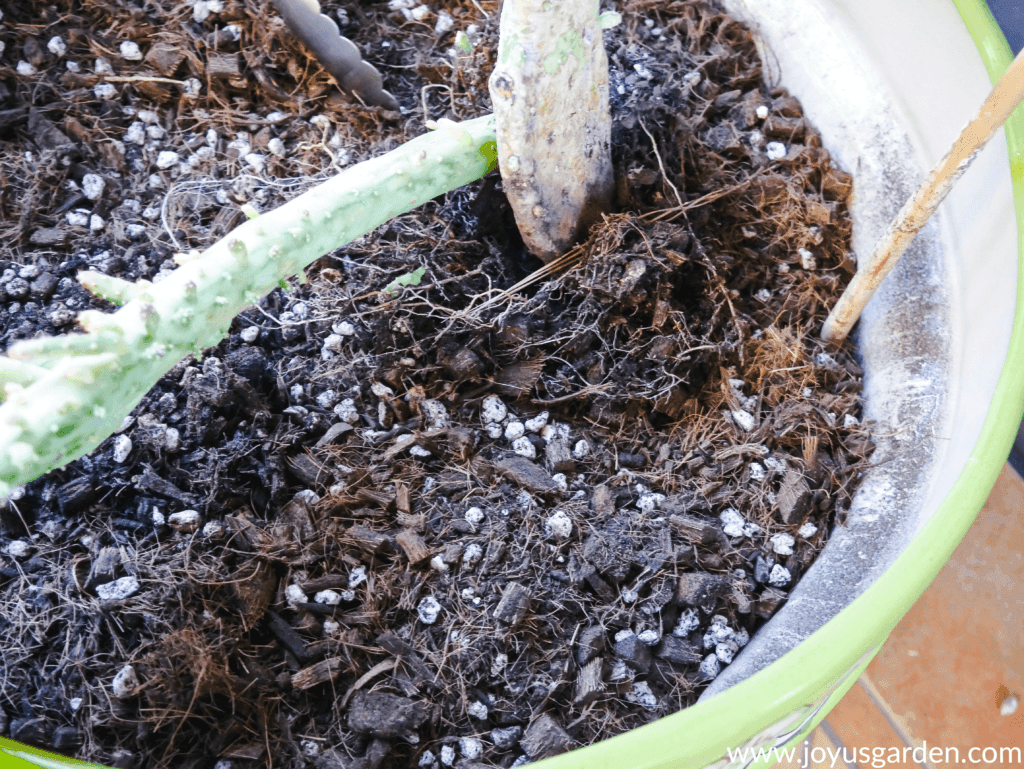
[821,51,1024,343]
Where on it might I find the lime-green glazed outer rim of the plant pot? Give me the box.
[0,0,1024,769]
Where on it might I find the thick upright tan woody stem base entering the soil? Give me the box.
[490,0,614,262]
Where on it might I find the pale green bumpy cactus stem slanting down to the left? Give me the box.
[0,116,498,498]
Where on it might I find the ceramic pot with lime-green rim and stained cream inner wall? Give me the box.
[0,0,1024,769]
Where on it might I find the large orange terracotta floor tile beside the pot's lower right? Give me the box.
[856,466,1024,768]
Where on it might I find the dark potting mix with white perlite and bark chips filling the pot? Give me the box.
[0,0,870,769]
